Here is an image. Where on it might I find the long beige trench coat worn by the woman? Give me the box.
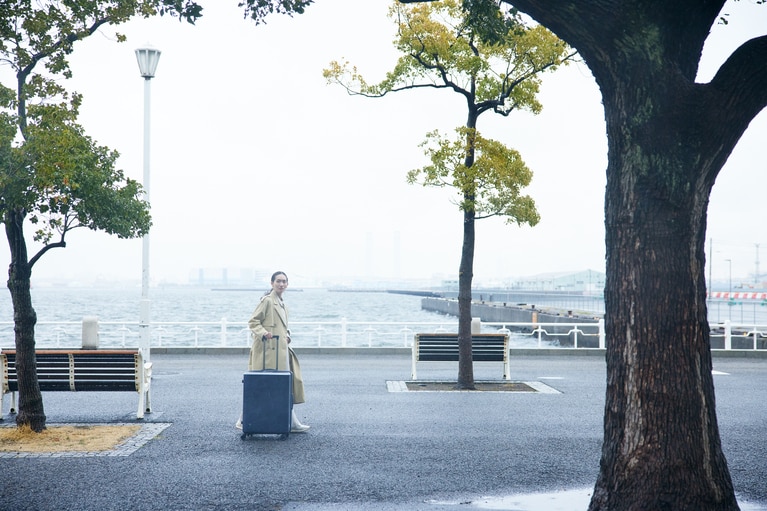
[248,291,305,404]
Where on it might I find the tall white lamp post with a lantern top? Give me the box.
[136,46,160,362]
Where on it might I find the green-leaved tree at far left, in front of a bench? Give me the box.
[0,0,201,432]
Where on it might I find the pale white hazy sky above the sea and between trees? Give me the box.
[0,0,767,285]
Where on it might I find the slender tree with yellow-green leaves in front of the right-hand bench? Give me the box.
[324,0,573,388]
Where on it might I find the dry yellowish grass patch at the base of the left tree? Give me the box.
[0,424,141,452]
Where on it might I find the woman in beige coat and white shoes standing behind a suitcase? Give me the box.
[237,271,309,433]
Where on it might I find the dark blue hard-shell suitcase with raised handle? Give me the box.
[242,336,293,440]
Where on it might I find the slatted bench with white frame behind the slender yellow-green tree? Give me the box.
[411,333,511,380]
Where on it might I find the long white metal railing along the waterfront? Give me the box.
[0,318,767,350]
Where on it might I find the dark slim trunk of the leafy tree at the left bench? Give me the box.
[5,210,45,432]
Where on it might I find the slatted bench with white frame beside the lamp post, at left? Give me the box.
[0,349,152,420]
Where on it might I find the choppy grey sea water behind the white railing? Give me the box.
[0,286,472,348]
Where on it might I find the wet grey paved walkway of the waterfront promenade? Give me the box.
[0,353,767,511]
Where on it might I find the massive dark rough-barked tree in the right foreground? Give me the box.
[492,0,767,511]
